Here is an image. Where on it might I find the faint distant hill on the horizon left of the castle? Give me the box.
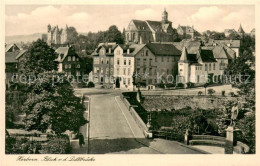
[5,33,43,44]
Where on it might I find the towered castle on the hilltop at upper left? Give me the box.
[47,24,68,45]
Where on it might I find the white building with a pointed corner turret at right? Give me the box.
[178,45,235,84]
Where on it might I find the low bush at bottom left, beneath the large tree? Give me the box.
[41,135,71,154]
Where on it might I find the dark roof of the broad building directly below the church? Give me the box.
[146,43,181,56]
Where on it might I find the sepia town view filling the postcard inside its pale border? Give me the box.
[1,0,256,161]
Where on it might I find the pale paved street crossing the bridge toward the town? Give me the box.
[72,89,202,154]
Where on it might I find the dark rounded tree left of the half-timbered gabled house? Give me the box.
[19,39,57,76]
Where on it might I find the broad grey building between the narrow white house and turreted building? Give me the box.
[135,43,181,86]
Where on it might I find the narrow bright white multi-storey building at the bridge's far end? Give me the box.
[114,44,145,90]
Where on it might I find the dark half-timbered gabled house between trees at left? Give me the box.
[55,46,86,79]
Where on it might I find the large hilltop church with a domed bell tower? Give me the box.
[125,9,177,44]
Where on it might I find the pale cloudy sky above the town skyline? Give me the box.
[5,5,255,36]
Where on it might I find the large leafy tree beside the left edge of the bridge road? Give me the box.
[22,71,87,134]
